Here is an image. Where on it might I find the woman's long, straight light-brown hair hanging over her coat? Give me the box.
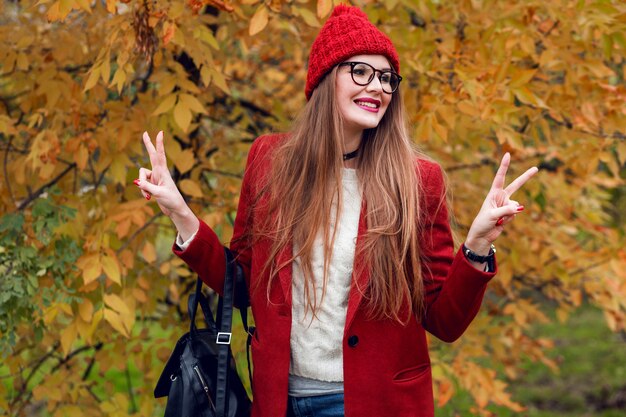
[246,67,424,323]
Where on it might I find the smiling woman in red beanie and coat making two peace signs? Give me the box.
[136,6,537,417]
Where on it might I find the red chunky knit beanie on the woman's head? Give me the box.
[304,4,400,100]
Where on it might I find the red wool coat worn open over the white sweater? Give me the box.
[174,135,495,417]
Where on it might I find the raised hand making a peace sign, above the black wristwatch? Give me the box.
[465,152,539,255]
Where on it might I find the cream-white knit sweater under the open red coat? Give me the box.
[289,169,361,381]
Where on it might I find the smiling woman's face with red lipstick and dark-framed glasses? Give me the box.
[335,55,392,137]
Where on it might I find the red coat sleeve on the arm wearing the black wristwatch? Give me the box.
[420,162,497,342]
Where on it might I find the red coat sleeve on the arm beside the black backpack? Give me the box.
[172,138,261,295]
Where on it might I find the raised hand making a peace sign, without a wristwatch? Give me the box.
[134,131,199,240]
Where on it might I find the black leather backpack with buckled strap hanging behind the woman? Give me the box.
[154,248,254,417]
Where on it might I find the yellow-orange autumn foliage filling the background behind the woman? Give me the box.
[0,0,626,416]
